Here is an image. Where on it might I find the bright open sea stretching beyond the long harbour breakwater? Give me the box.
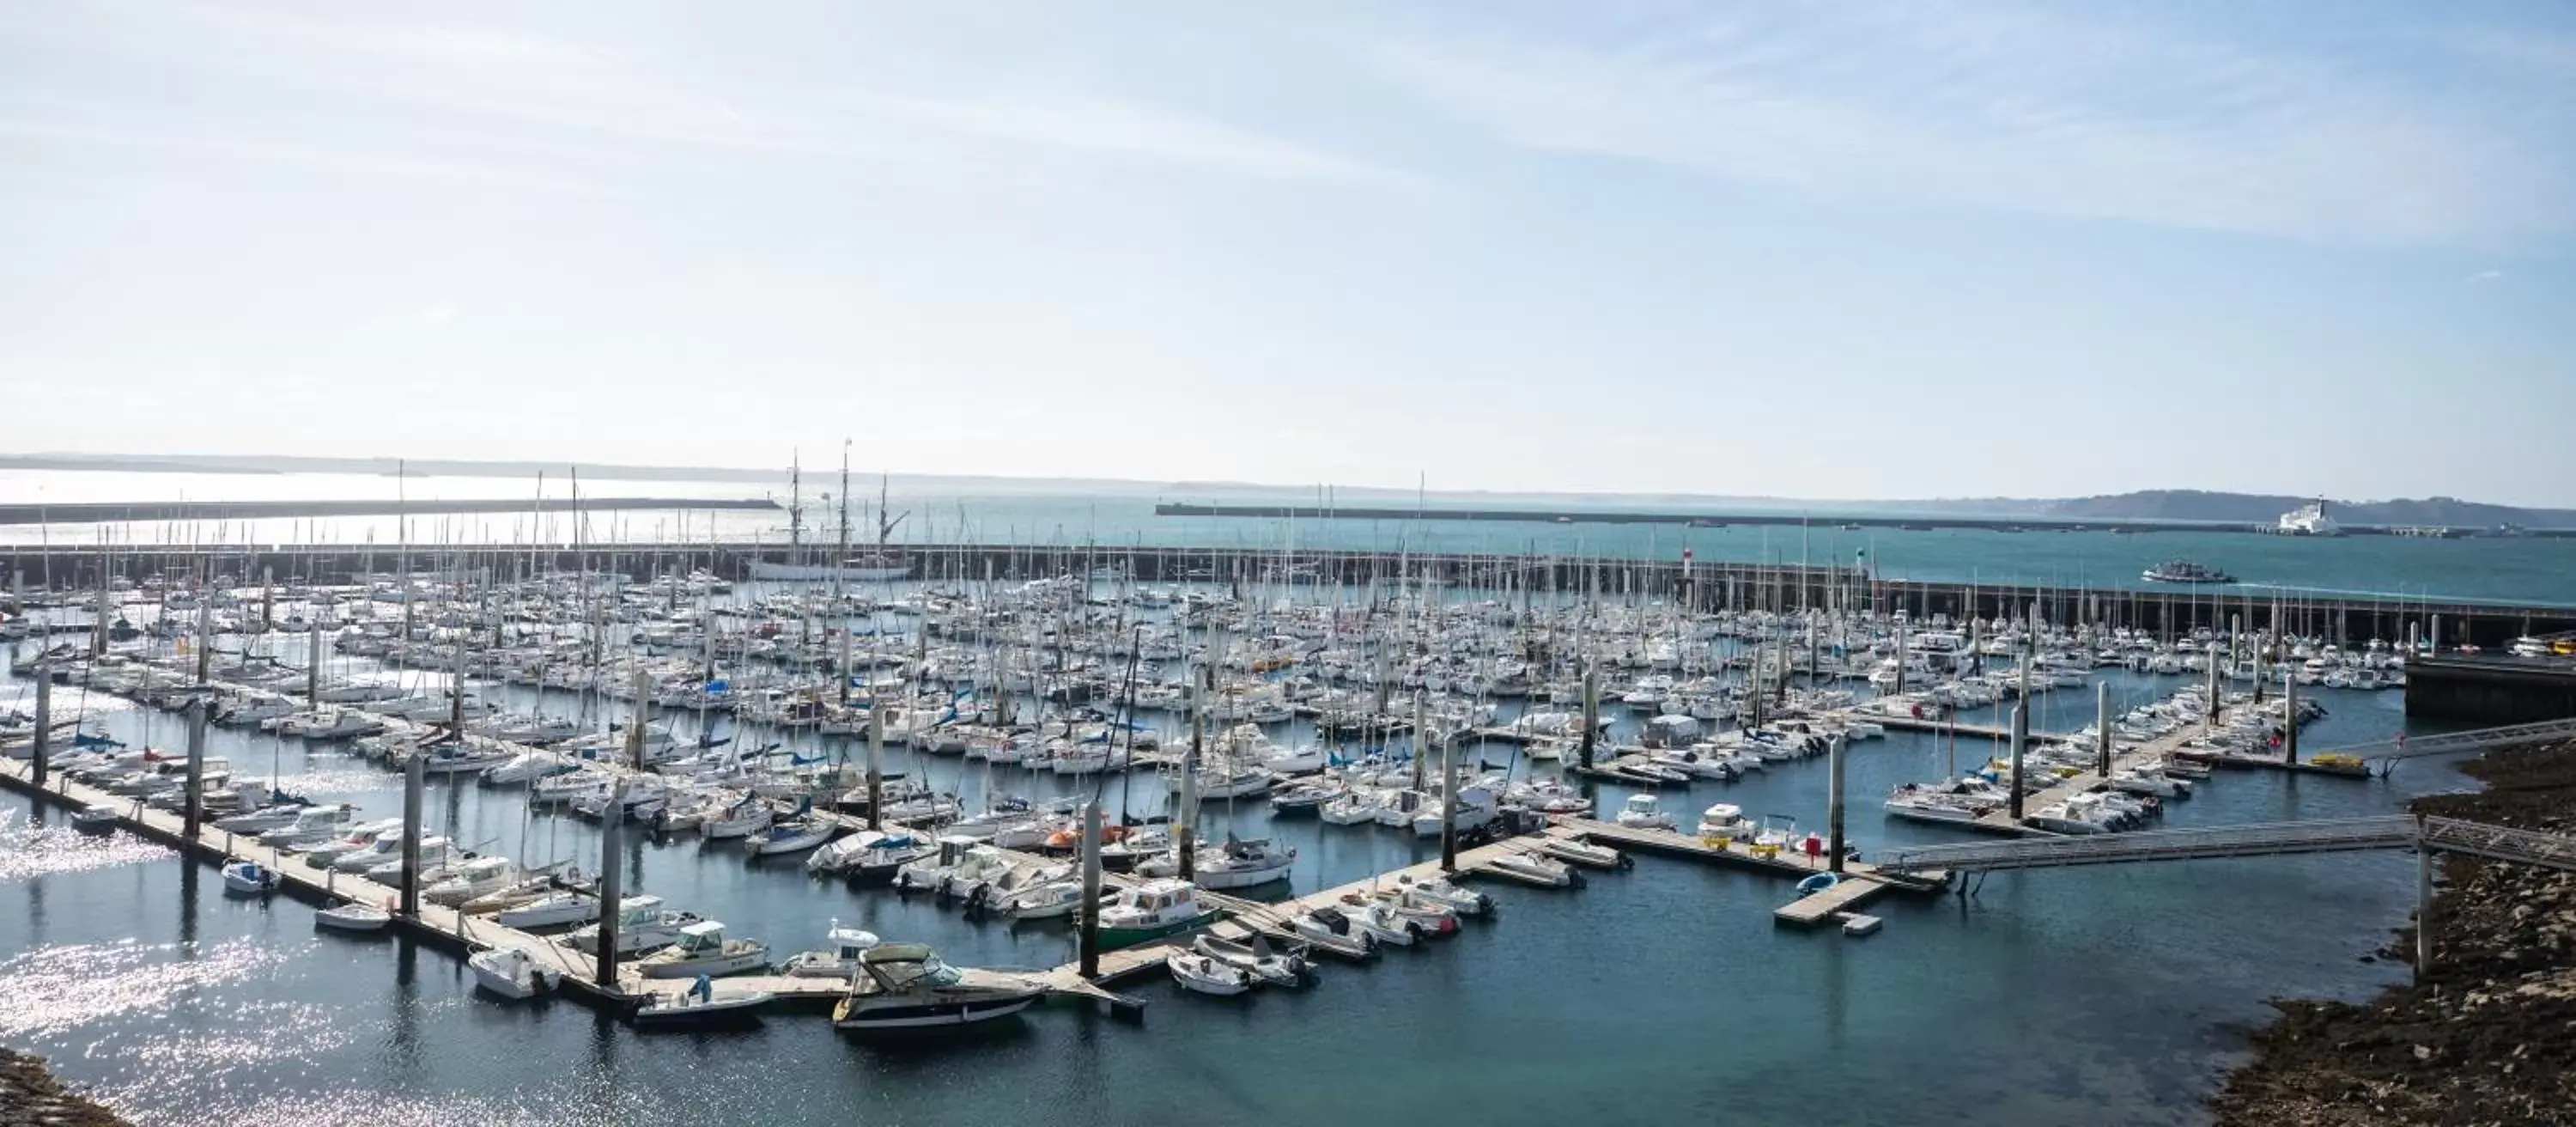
[0,469,2576,606]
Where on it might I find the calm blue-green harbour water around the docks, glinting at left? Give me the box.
[0,642,2468,1124]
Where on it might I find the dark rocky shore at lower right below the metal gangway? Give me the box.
[2213,743,2576,1127]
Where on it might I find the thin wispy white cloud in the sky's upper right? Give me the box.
[1352,3,2576,245]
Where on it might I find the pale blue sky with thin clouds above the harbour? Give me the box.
[0,0,2576,505]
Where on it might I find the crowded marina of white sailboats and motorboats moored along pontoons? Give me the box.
[0,528,2545,1124]
